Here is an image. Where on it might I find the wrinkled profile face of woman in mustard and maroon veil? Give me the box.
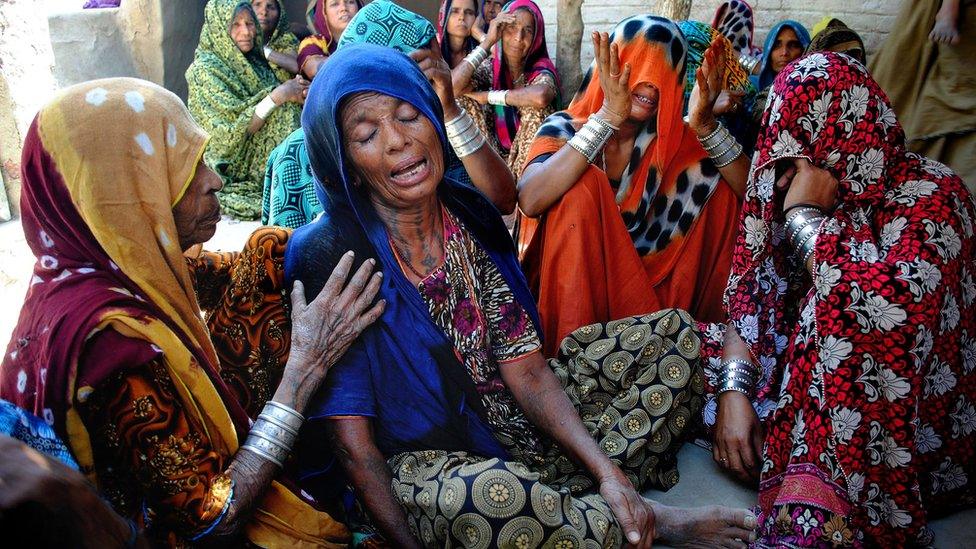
[173,160,223,251]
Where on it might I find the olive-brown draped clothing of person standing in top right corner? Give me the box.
[871,0,976,191]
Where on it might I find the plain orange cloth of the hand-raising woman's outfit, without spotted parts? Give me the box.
[518,18,739,356]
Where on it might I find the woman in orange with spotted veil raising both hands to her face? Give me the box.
[519,16,744,356]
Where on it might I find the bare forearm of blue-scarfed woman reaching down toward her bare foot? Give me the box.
[499,351,654,545]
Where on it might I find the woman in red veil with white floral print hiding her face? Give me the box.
[703,53,976,547]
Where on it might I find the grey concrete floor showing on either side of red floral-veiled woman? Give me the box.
[644,444,976,549]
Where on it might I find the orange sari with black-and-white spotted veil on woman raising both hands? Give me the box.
[518,15,738,356]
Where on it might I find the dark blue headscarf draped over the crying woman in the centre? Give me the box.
[285,44,539,488]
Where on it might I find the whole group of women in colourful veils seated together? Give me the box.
[0,0,976,548]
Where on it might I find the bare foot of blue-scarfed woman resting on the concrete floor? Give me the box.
[651,501,756,549]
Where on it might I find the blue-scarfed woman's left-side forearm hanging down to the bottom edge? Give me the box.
[329,417,421,548]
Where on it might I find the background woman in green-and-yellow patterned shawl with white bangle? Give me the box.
[186,0,308,219]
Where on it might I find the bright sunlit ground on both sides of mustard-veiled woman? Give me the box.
[0,217,259,349]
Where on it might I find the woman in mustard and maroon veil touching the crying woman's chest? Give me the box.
[0,78,382,547]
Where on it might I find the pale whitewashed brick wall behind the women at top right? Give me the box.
[536,0,900,71]
